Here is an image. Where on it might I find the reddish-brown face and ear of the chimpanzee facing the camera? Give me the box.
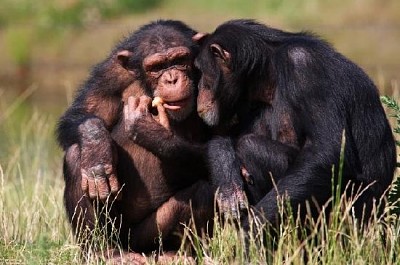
[119,32,196,121]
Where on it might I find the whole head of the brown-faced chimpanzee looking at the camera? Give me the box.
[115,20,198,121]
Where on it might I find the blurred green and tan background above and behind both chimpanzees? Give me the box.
[0,0,400,114]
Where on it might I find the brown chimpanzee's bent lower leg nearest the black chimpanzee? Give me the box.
[130,180,214,252]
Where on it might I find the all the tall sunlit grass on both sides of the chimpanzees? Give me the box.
[0,90,400,264]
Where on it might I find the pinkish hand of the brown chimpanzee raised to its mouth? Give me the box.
[124,96,169,134]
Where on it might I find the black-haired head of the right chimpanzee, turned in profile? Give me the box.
[193,20,273,126]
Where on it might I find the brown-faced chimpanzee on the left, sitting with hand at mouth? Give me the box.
[57,20,214,258]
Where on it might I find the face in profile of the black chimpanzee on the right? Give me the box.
[195,43,236,126]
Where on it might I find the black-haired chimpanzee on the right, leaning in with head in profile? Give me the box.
[194,20,396,227]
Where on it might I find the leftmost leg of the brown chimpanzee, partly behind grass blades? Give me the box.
[64,144,120,250]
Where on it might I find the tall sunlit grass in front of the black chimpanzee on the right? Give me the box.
[180,187,400,265]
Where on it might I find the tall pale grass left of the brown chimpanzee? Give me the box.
[0,90,79,264]
